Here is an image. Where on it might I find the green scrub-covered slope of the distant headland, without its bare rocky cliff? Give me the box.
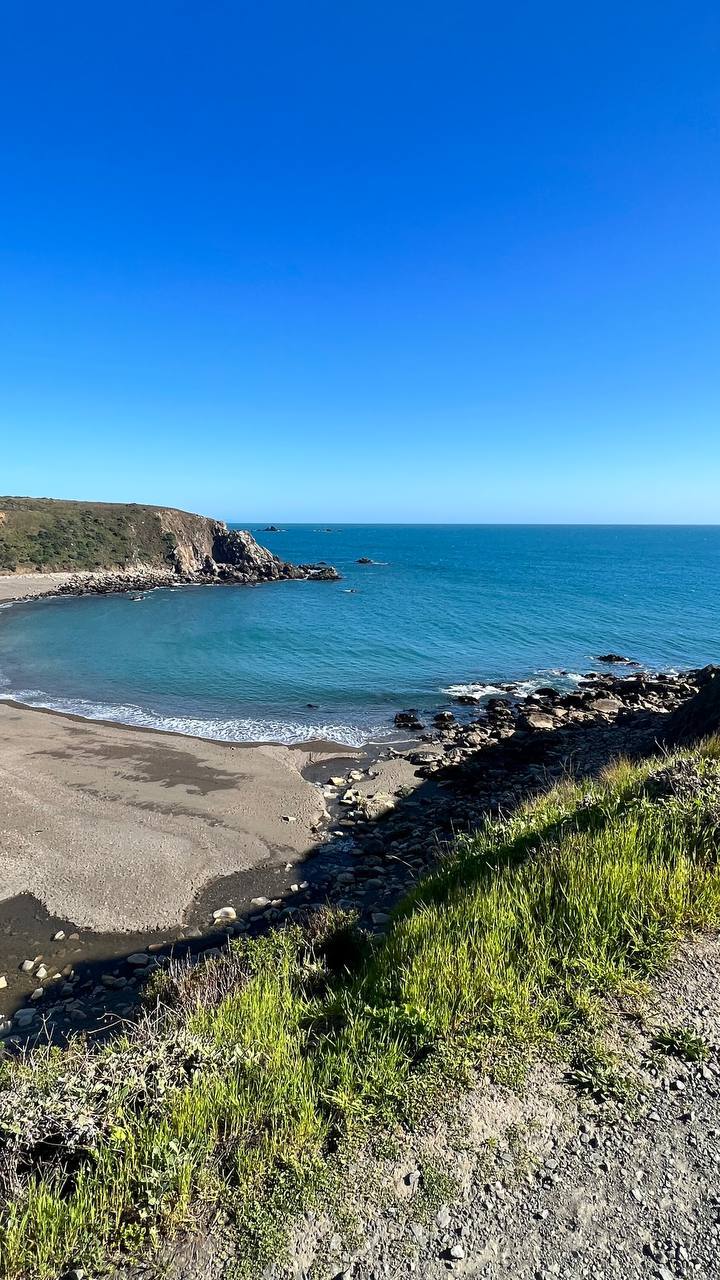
[0,498,200,573]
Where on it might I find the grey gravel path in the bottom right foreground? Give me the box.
[262,940,720,1280]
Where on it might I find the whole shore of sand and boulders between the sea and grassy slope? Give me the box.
[0,568,706,1034]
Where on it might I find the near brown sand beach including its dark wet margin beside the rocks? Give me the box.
[0,703,363,1014]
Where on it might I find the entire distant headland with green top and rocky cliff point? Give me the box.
[0,498,338,582]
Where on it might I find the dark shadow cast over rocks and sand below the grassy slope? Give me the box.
[0,710,666,1052]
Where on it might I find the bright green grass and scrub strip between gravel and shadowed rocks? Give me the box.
[0,744,720,1280]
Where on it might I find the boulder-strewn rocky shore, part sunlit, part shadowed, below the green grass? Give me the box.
[0,667,720,1047]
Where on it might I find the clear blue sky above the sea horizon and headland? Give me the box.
[0,0,720,522]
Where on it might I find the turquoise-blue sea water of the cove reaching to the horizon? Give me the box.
[0,525,720,742]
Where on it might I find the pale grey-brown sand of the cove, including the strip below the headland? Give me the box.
[0,573,352,933]
